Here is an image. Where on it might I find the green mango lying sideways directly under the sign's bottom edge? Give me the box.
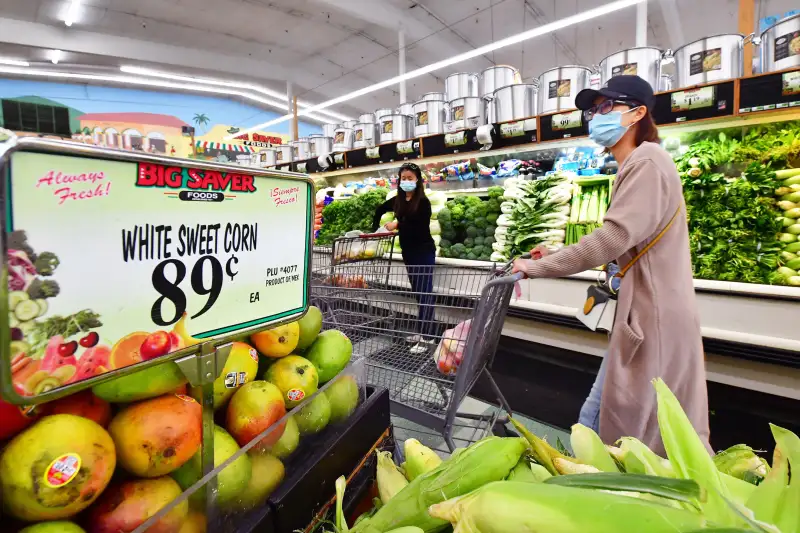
[92,361,187,403]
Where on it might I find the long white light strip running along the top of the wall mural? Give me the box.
[0,65,330,123]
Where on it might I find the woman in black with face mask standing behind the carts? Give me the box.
[372,163,436,353]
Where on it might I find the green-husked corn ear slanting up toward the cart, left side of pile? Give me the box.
[350,437,527,533]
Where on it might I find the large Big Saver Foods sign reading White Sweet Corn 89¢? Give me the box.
[0,141,314,398]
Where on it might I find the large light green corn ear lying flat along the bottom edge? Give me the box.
[430,481,706,533]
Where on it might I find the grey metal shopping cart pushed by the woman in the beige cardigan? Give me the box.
[312,234,520,451]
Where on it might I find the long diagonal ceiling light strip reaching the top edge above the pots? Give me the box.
[226,0,647,139]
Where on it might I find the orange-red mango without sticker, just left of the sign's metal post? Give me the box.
[108,394,203,478]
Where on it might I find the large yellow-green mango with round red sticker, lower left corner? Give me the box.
[0,415,117,522]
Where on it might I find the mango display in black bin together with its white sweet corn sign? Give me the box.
[0,132,389,533]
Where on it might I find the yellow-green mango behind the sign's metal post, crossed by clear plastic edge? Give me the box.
[172,426,252,506]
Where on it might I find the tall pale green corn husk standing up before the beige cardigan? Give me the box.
[653,378,741,526]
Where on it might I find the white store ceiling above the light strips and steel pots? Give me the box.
[0,0,798,121]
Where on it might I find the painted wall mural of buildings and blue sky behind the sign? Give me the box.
[0,79,321,162]
